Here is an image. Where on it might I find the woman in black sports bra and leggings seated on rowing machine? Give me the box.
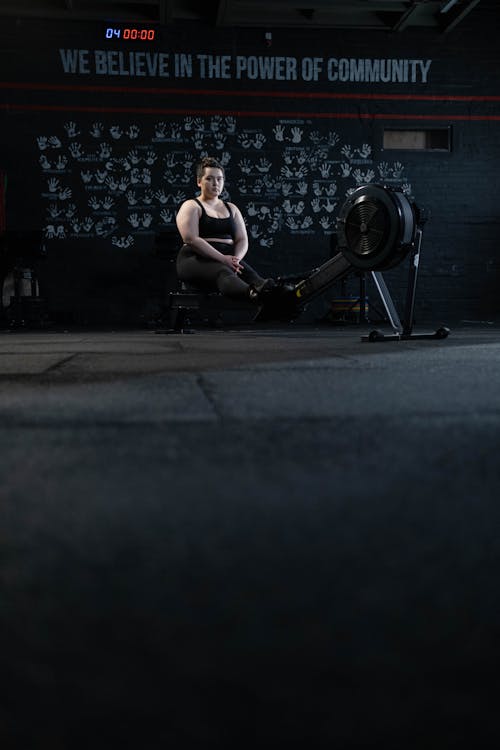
[176,157,274,303]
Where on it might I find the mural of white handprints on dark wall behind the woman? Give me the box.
[36,115,411,253]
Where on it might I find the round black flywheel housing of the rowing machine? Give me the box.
[337,184,419,271]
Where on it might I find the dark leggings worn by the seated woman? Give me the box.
[177,242,265,298]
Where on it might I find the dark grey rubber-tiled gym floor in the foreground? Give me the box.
[0,324,500,750]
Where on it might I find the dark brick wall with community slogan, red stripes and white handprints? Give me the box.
[0,6,500,322]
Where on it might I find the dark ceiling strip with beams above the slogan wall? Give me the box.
[0,0,488,32]
